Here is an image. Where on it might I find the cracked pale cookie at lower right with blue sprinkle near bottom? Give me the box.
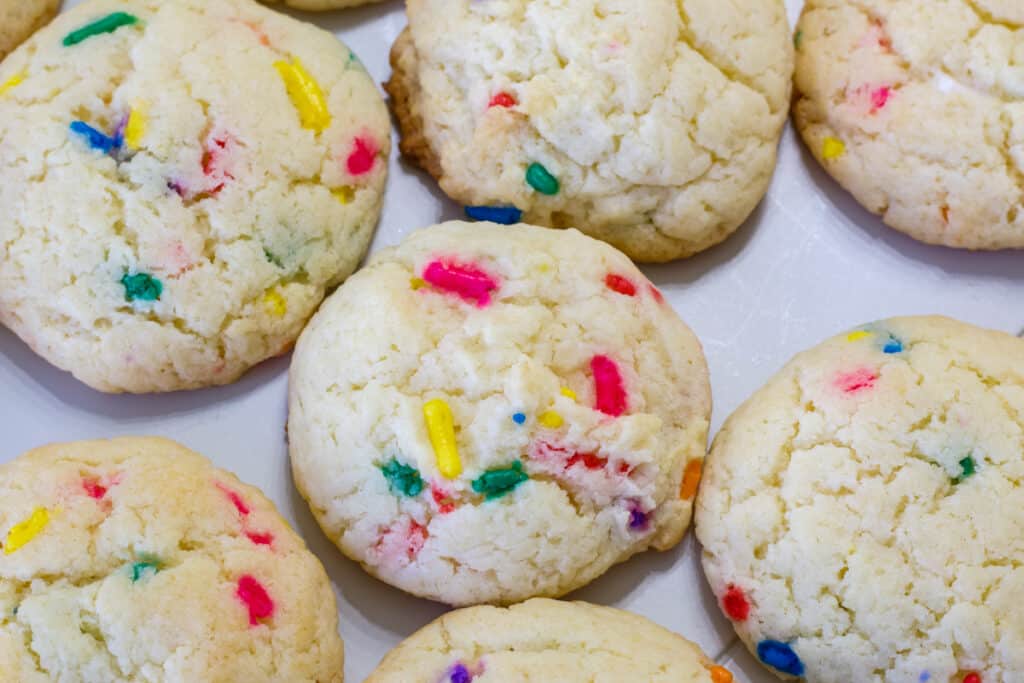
[696,317,1024,683]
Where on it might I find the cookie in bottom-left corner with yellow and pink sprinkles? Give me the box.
[0,438,343,683]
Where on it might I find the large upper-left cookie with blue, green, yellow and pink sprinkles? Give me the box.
[0,0,390,392]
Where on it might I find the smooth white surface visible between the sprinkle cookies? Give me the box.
[0,0,1024,683]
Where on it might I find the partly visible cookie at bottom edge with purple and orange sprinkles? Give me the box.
[367,598,732,683]
